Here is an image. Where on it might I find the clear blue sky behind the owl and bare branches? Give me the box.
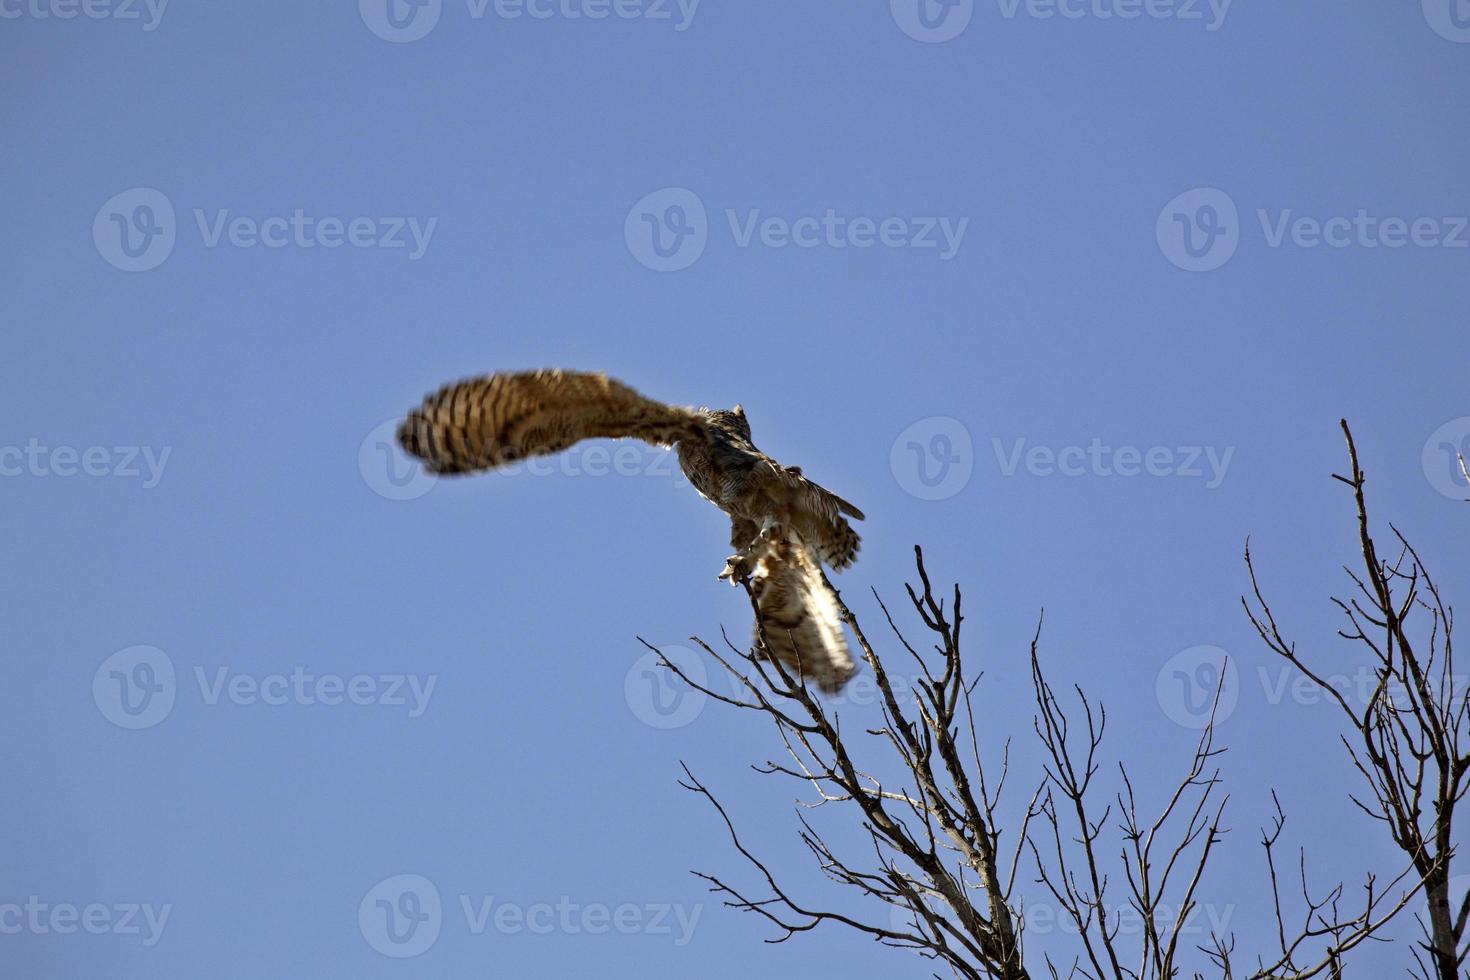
[0,0,1470,980]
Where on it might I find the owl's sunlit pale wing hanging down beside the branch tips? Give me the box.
[750,535,856,693]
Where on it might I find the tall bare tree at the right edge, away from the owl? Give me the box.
[1241,422,1470,980]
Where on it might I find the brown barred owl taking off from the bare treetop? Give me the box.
[398,370,863,692]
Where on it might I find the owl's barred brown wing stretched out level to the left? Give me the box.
[398,370,706,473]
